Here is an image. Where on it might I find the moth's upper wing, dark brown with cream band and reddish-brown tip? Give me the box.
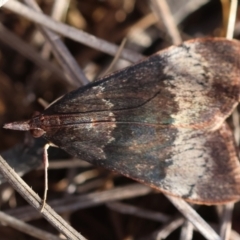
[45,38,240,129]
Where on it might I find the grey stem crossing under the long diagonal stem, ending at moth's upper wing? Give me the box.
[24,0,89,87]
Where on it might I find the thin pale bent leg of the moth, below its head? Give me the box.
[40,143,57,212]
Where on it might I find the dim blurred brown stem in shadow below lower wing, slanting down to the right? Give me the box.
[107,202,171,223]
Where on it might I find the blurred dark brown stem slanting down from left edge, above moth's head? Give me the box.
[0,24,64,79]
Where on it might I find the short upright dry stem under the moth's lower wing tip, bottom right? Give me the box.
[220,203,234,240]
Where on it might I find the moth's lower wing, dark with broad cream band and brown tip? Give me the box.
[45,123,240,204]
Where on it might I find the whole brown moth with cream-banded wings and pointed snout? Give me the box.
[4,38,240,204]
